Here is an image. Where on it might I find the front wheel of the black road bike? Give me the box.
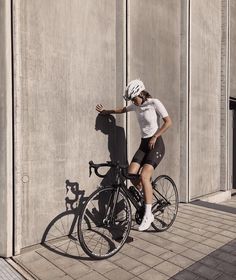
[78,187,132,259]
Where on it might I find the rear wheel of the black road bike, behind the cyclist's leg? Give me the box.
[152,175,179,231]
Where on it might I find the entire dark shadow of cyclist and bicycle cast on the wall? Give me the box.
[41,115,129,259]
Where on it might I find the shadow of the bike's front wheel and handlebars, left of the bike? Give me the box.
[41,180,88,260]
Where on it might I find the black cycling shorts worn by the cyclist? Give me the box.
[132,136,165,169]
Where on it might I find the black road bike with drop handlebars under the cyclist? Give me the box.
[78,161,179,259]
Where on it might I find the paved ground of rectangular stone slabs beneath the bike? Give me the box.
[14,196,236,280]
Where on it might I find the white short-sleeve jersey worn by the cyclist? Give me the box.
[126,98,168,138]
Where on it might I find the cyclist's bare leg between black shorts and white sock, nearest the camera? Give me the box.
[141,164,154,204]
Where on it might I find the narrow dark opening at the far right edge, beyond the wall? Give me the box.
[229,97,236,189]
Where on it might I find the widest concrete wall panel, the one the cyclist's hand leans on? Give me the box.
[13,0,125,249]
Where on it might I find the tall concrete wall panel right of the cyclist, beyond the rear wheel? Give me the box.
[189,0,222,198]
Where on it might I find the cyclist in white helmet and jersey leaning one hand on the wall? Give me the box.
[96,79,172,231]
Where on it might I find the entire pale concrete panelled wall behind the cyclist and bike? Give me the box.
[0,0,231,255]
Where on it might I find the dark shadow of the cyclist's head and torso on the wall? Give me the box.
[95,114,128,186]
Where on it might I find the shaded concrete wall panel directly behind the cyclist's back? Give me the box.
[128,0,183,192]
